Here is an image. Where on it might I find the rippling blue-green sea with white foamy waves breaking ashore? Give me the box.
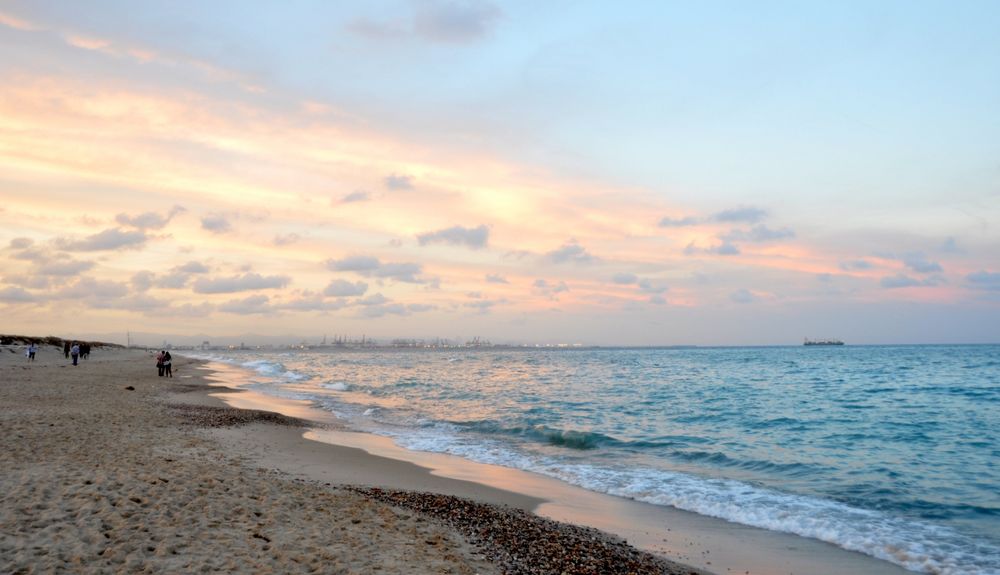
[191,345,1000,575]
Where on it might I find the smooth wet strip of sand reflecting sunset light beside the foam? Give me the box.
[193,361,912,575]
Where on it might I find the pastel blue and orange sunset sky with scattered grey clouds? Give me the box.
[0,0,1000,345]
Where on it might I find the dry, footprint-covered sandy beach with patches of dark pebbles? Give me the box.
[0,346,705,574]
